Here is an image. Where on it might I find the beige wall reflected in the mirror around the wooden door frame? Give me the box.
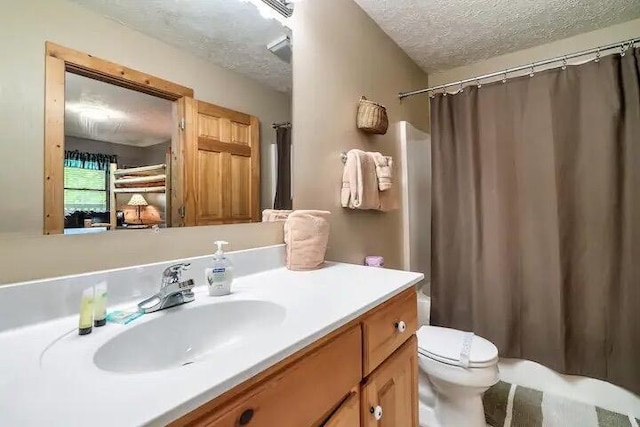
[0,0,291,233]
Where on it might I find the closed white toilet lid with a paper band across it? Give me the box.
[416,326,498,368]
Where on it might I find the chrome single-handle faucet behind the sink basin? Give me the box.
[138,263,195,313]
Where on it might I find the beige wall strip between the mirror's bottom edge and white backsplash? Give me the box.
[0,223,283,285]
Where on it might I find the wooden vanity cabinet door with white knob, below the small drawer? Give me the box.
[361,335,418,427]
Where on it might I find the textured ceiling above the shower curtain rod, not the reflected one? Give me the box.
[356,0,640,72]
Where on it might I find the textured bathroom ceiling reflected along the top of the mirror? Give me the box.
[72,0,291,92]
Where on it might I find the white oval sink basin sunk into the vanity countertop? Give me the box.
[93,301,285,373]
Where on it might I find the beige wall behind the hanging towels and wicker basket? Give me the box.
[293,0,428,268]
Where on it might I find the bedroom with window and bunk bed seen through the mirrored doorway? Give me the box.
[64,72,174,234]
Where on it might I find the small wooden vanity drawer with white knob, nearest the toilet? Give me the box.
[362,287,418,376]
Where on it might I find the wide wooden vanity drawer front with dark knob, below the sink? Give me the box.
[192,326,362,427]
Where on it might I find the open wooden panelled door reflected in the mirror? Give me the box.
[174,98,260,226]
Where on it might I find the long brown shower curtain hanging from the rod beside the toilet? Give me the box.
[431,50,640,393]
